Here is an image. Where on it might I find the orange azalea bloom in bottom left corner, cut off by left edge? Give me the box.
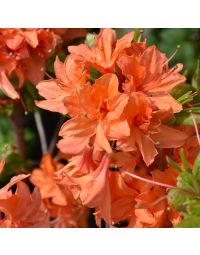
[0,175,48,228]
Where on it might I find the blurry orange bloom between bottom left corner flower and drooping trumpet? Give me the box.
[30,154,88,227]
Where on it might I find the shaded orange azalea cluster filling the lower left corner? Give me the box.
[0,154,88,228]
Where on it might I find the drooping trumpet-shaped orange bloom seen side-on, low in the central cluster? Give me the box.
[56,147,110,222]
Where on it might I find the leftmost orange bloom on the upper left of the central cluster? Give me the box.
[36,55,88,116]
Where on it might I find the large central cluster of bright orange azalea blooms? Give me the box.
[35,29,188,227]
